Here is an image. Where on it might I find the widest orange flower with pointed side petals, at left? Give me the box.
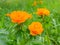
[7,11,31,24]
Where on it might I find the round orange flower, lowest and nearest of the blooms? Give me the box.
[28,22,43,36]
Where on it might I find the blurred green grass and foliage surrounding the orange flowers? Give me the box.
[0,0,60,45]
